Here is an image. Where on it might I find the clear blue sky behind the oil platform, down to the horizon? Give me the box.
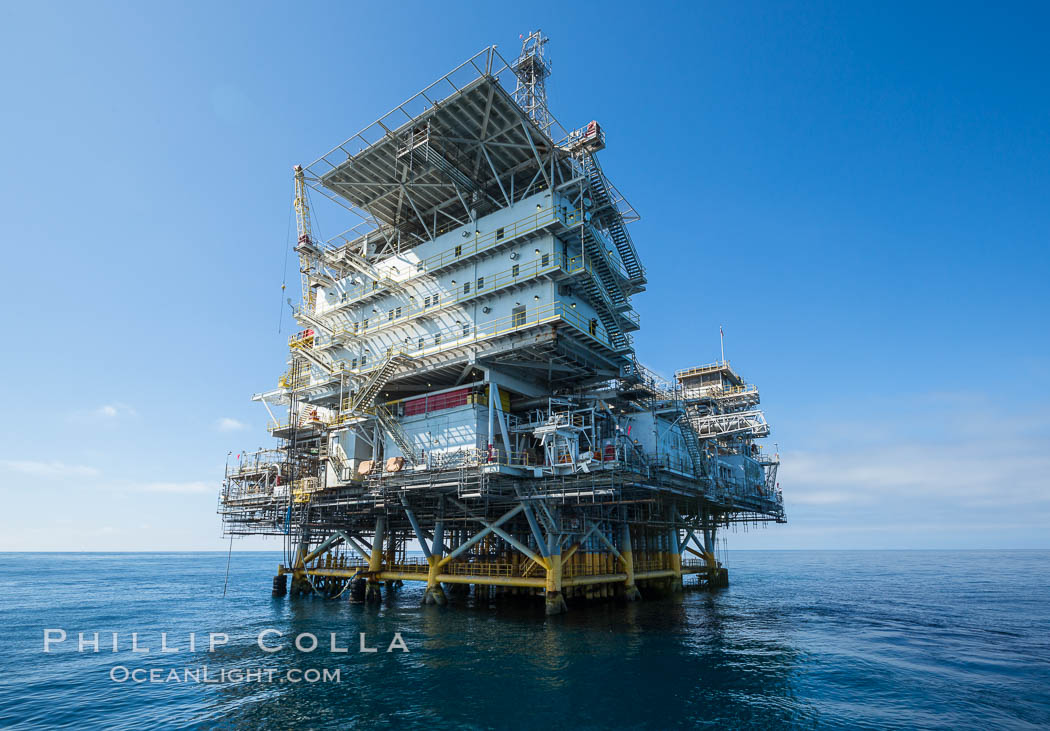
[0,2,1050,550]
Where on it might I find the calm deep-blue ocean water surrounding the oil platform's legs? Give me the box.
[0,551,1050,729]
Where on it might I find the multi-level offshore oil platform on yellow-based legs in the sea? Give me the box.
[218,32,784,613]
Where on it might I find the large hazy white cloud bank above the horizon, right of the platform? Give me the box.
[779,394,1050,510]
